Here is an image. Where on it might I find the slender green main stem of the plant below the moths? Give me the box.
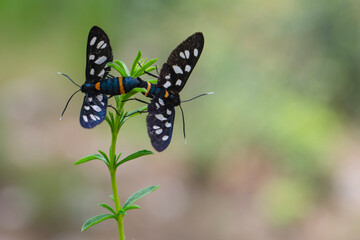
[109,124,125,240]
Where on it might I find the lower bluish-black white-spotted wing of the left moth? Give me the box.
[80,93,107,128]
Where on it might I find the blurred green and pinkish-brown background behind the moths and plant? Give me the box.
[0,0,360,240]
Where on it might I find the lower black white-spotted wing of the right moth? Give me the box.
[146,98,175,152]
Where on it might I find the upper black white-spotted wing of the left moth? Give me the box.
[85,26,113,83]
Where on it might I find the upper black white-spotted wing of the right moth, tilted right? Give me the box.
[157,32,204,93]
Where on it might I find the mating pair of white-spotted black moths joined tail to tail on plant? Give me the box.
[59,26,210,152]
